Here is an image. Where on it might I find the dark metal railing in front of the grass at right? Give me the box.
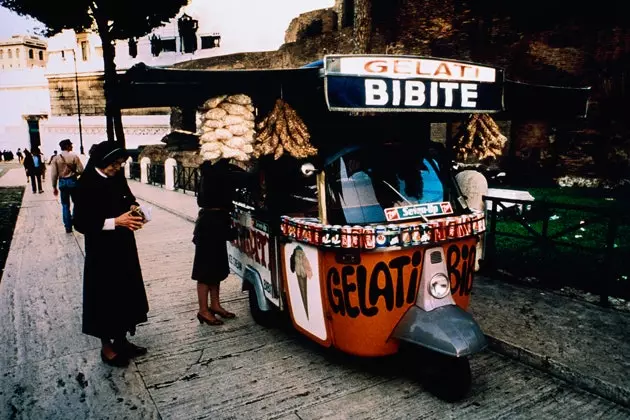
[483,196,630,306]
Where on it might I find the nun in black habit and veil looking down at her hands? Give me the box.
[73,141,149,366]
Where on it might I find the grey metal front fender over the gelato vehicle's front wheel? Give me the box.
[392,305,488,357]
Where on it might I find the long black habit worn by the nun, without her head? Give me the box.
[73,165,149,338]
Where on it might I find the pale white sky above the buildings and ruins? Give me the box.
[0,0,334,53]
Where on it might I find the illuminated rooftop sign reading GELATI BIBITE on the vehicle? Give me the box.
[324,55,504,113]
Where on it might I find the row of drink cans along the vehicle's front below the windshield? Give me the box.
[280,213,486,249]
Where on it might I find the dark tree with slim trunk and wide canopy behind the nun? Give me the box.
[0,0,188,147]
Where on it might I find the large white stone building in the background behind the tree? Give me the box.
[0,10,225,155]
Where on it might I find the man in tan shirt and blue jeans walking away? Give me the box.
[50,139,83,233]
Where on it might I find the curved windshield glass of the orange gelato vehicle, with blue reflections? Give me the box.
[326,145,448,225]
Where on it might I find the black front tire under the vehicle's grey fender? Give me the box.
[419,352,472,402]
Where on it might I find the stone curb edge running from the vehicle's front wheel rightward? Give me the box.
[486,335,630,408]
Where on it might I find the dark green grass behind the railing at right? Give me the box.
[496,188,630,297]
